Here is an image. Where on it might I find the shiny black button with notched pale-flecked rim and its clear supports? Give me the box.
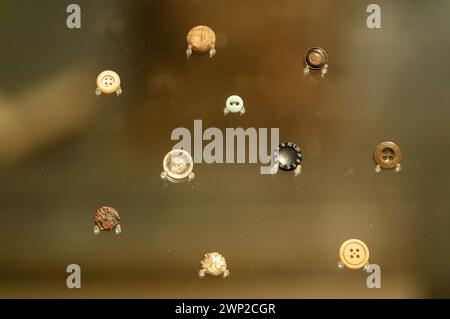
[272,142,302,176]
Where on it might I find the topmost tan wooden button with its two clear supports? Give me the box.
[186,25,216,58]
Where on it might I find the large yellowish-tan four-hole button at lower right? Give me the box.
[339,239,369,269]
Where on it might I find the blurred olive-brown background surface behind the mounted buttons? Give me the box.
[0,0,450,298]
